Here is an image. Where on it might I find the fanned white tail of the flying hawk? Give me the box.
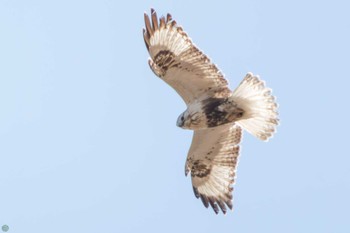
[232,73,279,141]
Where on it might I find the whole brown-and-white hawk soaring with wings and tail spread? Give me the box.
[143,9,279,214]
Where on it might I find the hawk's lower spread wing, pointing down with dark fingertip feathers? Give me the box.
[185,124,242,214]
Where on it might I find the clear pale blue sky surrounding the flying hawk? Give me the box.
[0,0,350,233]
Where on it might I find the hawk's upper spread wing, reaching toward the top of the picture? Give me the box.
[143,9,231,104]
